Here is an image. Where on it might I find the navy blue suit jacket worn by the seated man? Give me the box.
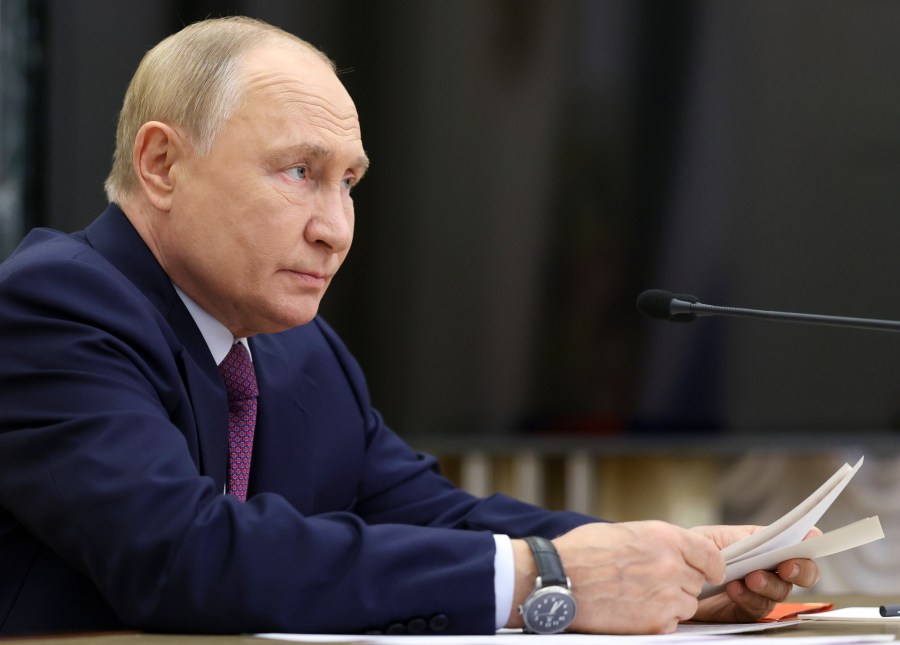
[0,206,591,634]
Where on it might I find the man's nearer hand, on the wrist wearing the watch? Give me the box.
[510,521,725,634]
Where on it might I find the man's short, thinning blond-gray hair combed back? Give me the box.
[105,16,335,204]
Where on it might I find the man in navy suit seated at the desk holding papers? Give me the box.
[0,13,818,635]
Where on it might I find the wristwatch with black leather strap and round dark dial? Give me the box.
[519,537,575,634]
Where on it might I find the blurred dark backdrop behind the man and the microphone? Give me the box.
[0,0,900,436]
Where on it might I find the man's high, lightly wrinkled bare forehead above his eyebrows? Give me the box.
[234,42,361,146]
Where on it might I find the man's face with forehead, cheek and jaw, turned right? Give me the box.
[157,44,367,336]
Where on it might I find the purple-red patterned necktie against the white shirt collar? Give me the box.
[219,343,259,502]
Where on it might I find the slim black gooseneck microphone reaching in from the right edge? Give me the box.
[637,289,900,331]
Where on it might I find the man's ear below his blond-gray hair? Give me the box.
[132,121,187,211]
